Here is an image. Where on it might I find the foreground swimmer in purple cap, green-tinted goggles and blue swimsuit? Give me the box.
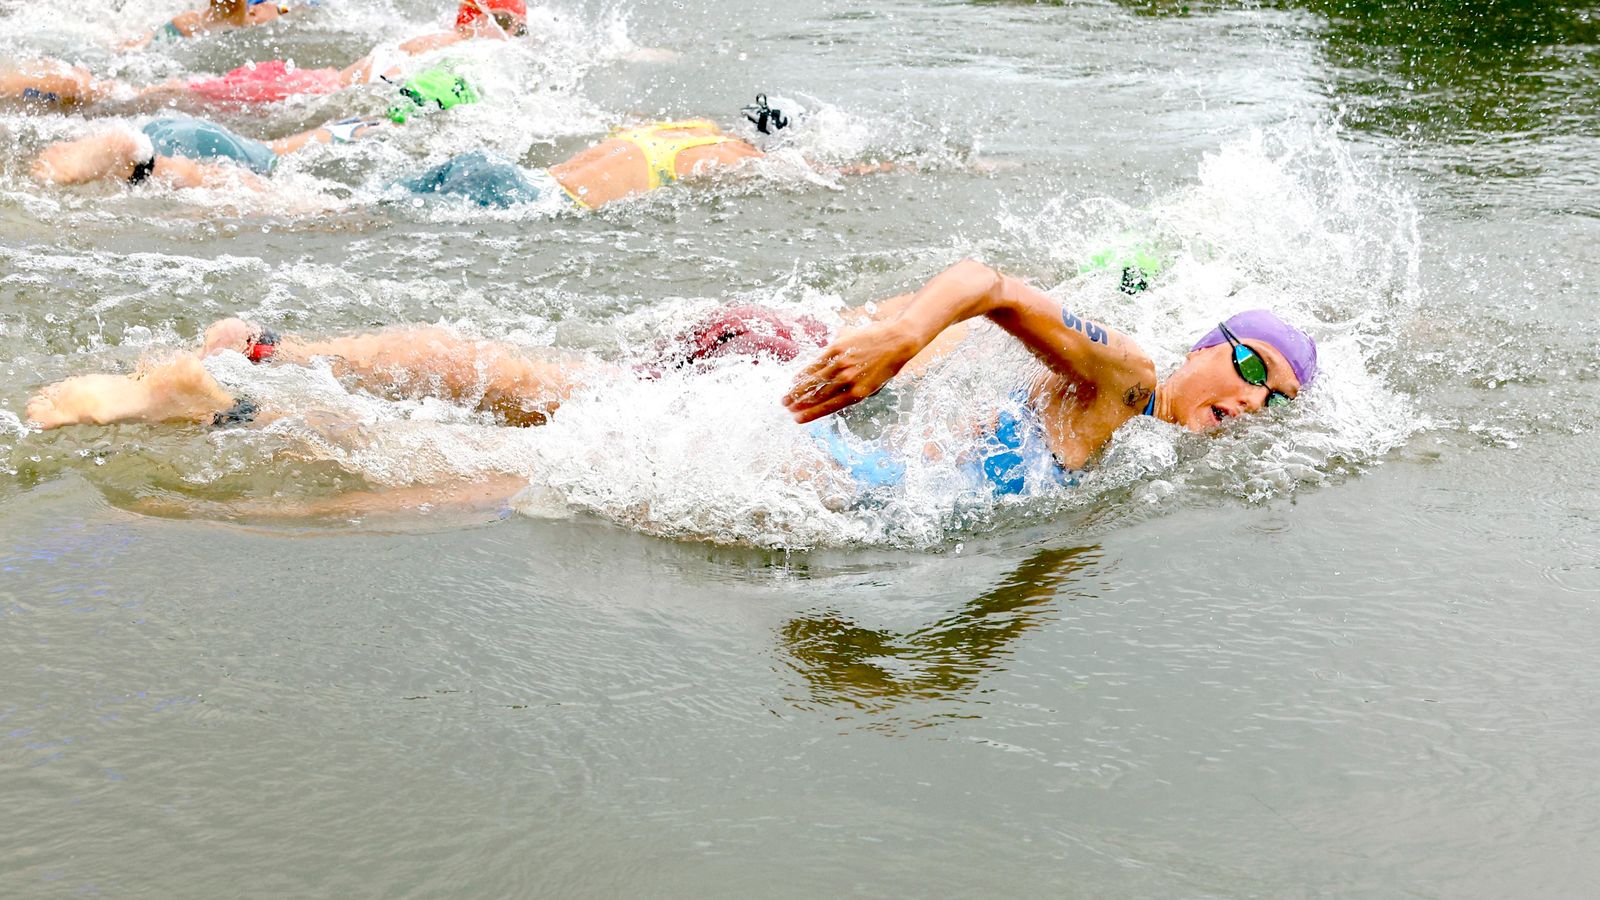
[27,259,1317,506]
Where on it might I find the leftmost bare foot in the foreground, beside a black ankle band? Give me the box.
[27,357,234,429]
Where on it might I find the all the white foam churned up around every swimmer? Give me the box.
[0,3,1429,548]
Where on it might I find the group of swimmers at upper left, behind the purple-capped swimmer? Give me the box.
[15,0,825,210]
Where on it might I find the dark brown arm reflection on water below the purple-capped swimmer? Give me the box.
[779,544,1101,713]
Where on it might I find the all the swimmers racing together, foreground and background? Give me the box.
[12,0,1317,515]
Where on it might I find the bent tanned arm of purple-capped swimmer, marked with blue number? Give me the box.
[782,259,1155,423]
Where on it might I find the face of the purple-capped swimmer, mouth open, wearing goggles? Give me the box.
[1162,338,1299,431]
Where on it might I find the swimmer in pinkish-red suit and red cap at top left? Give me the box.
[0,0,528,109]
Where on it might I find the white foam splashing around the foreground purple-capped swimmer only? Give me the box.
[103,118,1427,548]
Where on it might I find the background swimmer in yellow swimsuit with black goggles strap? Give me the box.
[402,94,886,211]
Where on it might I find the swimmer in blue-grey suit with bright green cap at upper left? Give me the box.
[32,67,478,191]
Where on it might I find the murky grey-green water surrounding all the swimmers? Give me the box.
[0,0,1600,897]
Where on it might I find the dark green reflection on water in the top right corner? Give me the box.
[1115,0,1600,203]
